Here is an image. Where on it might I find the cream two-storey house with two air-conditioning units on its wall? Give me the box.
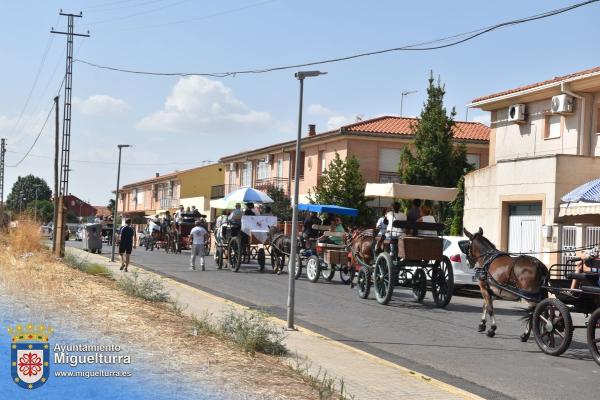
[464,67,600,263]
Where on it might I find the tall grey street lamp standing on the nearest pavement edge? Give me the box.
[287,71,327,330]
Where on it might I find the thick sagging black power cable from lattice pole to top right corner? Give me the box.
[74,0,600,78]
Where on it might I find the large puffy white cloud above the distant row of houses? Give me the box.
[136,76,273,134]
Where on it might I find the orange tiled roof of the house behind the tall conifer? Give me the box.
[342,116,490,141]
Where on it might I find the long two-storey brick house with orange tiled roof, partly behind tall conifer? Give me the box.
[219,116,489,202]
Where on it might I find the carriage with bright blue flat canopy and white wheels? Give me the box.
[296,204,358,284]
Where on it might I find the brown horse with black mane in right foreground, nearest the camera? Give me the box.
[463,228,548,342]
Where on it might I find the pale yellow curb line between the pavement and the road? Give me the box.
[70,249,485,400]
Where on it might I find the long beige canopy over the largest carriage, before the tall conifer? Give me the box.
[365,183,458,201]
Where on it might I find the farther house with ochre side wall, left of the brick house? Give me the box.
[118,164,224,223]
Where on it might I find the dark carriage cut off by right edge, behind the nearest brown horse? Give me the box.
[532,258,600,364]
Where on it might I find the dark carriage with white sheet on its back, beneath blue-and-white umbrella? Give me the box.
[215,215,277,272]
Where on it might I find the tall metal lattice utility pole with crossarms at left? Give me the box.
[50,10,90,257]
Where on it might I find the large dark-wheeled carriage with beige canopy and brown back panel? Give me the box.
[353,183,457,307]
